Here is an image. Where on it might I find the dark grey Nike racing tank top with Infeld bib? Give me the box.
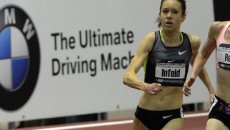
[145,31,192,87]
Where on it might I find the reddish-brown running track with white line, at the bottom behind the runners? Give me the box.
[16,112,208,130]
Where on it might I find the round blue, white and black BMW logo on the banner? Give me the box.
[0,5,40,111]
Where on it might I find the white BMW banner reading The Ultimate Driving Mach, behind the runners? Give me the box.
[0,0,215,122]
